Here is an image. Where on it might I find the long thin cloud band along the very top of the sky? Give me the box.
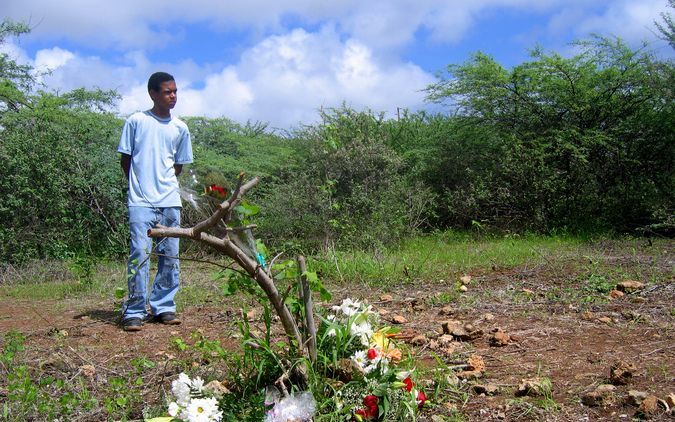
[3,0,604,49]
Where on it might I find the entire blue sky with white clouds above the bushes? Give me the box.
[0,0,673,129]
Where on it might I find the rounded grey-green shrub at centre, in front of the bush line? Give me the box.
[260,108,433,250]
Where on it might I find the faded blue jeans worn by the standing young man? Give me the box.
[122,207,181,320]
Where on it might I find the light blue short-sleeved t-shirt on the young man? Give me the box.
[117,110,192,208]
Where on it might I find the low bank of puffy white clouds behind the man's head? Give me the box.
[16,26,433,128]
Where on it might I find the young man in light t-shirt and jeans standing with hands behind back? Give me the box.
[117,72,192,331]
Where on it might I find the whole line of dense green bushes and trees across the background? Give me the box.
[0,22,675,263]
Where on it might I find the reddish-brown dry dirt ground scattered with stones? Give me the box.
[0,243,675,421]
